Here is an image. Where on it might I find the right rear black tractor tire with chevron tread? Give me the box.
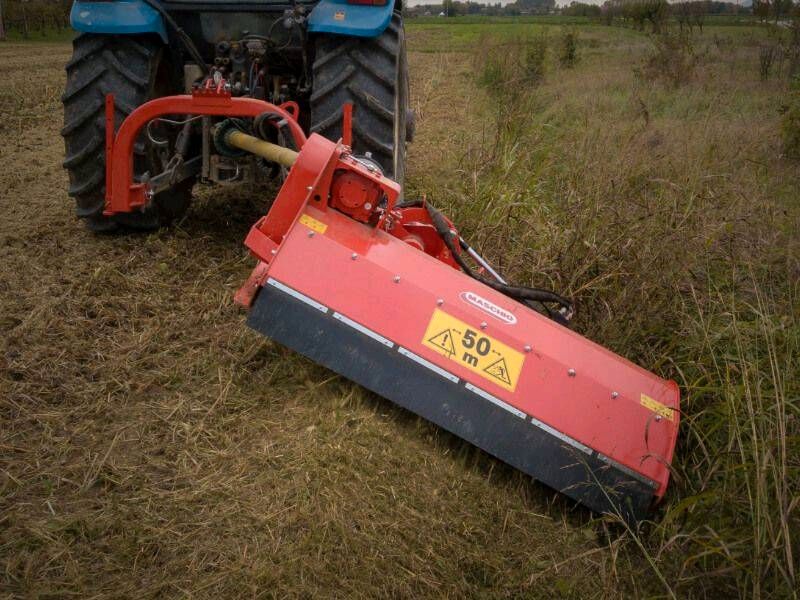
[311,13,411,183]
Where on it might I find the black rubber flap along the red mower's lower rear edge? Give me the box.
[247,280,655,522]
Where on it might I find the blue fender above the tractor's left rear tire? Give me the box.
[69,0,167,43]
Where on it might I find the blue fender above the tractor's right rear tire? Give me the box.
[308,0,394,38]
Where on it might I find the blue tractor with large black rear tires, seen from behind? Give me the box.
[62,0,413,231]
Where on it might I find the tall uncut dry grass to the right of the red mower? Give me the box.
[450,27,800,597]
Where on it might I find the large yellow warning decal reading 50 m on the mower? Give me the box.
[422,308,525,392]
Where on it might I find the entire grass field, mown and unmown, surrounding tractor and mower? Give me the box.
[0,21,800,598]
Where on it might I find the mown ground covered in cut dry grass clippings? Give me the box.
[0,36,627,598]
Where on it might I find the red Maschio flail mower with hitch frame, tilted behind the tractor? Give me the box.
[104,81,679,523]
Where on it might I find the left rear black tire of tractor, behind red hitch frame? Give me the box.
[61,34,192,231]
